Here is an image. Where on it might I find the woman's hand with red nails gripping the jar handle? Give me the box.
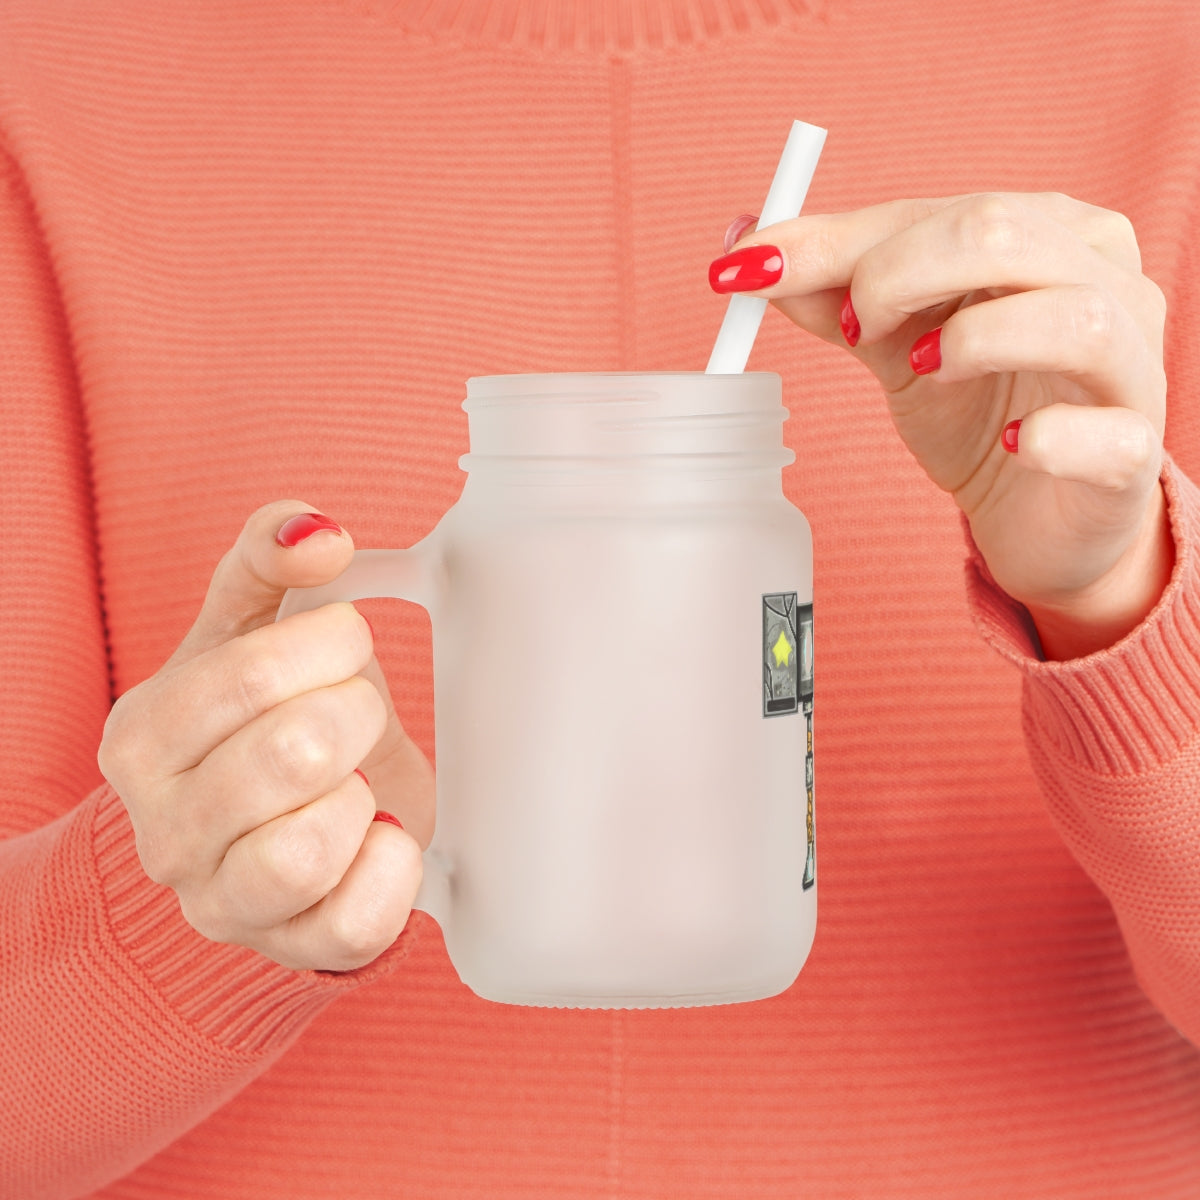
[98,500,433,971]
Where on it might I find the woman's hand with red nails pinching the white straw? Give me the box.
[709,193,1174,659]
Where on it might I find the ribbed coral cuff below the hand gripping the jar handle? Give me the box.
[92,785,419,1057]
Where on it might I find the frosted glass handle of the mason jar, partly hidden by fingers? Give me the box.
[275,538,451,930]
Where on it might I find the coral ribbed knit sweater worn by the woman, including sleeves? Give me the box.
[0,0,1200,1200]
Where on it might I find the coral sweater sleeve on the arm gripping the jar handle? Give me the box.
[0,155,417,1200]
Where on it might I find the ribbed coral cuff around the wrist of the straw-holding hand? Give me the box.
[962,456,1200,774]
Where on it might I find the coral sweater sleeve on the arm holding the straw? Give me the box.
[964,457,1200,1045]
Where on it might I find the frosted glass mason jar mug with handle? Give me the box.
[280,373,816,1008]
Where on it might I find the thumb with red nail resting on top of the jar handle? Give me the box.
[167,500,354,667]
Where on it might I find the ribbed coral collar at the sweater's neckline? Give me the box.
[347,0,828,53]
